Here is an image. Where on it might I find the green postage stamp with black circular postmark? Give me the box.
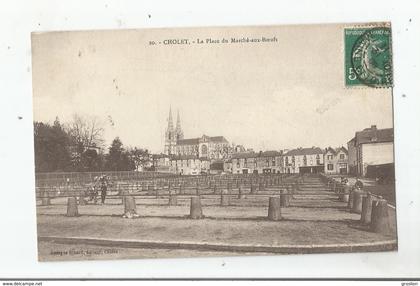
[344,26,393,87]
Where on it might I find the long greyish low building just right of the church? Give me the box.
[232,151,282,174]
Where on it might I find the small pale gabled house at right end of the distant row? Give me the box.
[324,147,349,174]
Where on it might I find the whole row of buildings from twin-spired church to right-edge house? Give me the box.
[152,110,394,176]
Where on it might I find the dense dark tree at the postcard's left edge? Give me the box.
[34,117,71,172]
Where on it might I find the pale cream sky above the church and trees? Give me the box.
[32,24,393,153]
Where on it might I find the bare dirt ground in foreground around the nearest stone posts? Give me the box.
[37,177,397,261]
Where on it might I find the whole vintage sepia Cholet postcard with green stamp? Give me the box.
[32,23,398,261]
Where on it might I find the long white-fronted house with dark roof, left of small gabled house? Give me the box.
[283,147,324,174]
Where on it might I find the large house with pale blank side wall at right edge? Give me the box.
[347,125,394,176]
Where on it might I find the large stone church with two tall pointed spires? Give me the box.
[164,108,232,161]
